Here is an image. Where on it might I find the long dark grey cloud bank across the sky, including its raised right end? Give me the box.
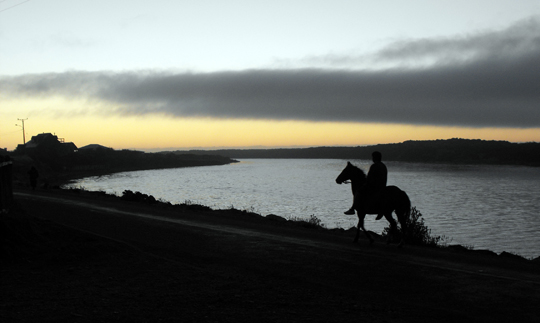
[4,19,540,128]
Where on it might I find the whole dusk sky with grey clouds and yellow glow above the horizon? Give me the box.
[0,0,540,150]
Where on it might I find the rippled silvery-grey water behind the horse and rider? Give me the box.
[66,159,540,258]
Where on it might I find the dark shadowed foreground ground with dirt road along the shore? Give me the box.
[0,189,540,322]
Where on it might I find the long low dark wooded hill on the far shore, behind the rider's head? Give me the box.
[190,138,540,166]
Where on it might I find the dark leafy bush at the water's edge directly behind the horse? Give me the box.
[382,207,448,247]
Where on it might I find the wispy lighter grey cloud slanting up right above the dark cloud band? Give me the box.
[296,18,540,69]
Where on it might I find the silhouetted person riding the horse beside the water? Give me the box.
[345,151,388,220]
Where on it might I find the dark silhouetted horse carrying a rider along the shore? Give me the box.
[336,162,411,246]
